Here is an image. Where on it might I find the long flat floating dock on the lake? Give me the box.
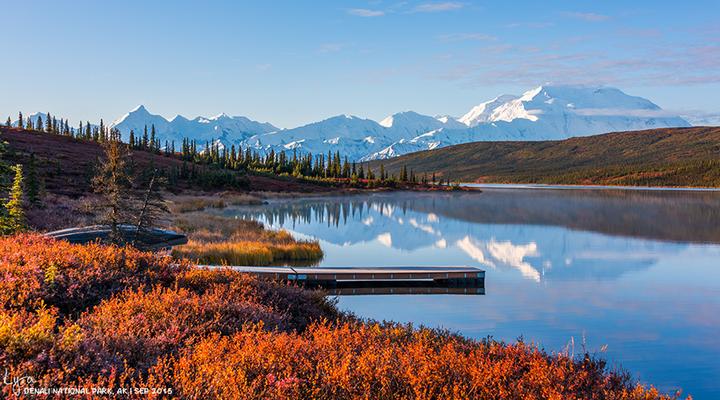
[200,266,485,295]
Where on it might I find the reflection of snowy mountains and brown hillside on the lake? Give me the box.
[219,189,720,282]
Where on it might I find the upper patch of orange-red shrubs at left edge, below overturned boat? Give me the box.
[0,234,187,313]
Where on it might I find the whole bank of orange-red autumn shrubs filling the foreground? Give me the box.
[0,235,680,399]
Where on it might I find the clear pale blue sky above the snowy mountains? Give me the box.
[0,0,720,127]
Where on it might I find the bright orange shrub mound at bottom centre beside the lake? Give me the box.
[150,322,676,399]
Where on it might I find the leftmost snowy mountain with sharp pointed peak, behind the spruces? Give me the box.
[110,105,278,145]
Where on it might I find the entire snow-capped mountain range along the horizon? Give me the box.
[111,85,690,161]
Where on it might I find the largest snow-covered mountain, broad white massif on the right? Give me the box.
[365,86,690,160]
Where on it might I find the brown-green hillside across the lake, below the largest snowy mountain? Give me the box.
[371,127,720,187]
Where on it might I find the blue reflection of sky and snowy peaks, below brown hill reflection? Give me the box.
[225,192,720,398]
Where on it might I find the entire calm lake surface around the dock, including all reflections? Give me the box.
[222,187,720,399]
